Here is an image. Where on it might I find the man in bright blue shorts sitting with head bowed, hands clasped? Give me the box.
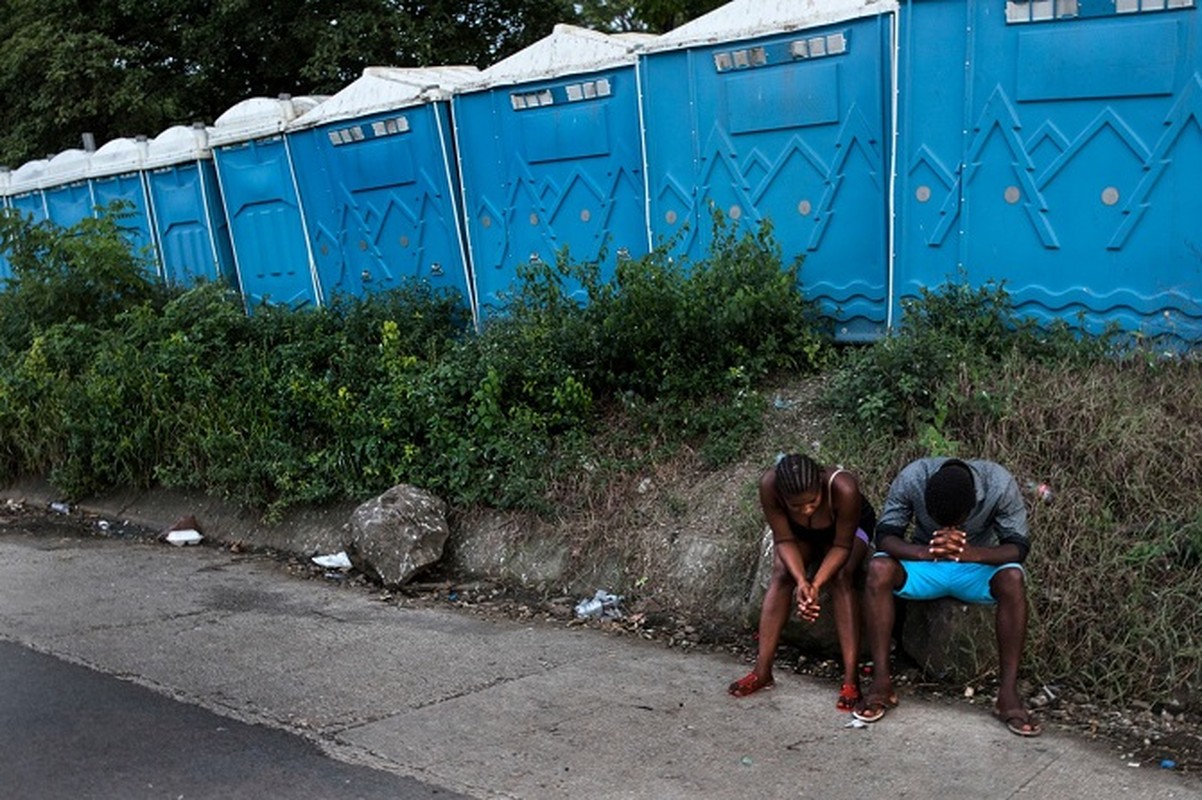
[855,458,1042,736]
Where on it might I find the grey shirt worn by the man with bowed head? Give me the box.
[874,458,1030,561]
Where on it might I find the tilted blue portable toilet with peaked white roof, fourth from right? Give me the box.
[286,66,480,306]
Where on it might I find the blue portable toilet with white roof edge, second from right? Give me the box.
[639,0,897,341]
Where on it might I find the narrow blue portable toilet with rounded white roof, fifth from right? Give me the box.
[209,95,321,310]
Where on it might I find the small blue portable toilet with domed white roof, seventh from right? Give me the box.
[88,138,162,279]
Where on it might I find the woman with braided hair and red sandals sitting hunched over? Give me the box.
[728,454,876,711]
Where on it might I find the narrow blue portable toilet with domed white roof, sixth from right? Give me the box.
[143,125,237,287]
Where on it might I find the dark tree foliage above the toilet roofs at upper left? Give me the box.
[0,0,576,167]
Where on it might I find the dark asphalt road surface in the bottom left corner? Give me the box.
[0,641,463,800]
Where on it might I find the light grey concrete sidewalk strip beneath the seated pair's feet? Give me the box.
[0,514,1202,800]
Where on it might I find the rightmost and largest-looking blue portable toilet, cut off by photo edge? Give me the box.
[897,0,1202,342]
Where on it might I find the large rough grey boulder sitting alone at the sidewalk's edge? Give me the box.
[349,484,450,586]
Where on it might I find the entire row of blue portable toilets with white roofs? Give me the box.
[0,0,1202,342]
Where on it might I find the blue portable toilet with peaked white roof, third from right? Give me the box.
[453,24,654,317]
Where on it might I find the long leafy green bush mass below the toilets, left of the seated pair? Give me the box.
[0,209,823,512]
